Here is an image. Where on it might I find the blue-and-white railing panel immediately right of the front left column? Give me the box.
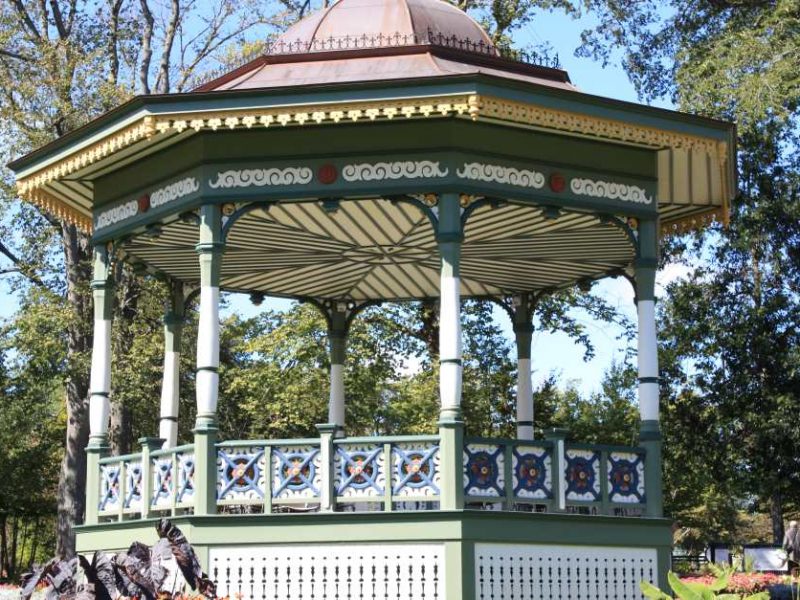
[217,448,266,502]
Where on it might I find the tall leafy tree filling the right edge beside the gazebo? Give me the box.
[582,0,800,543]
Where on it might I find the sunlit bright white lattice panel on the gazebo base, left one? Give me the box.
[209,544,447,600]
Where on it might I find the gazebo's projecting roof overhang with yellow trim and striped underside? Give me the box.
[9,75,736,232]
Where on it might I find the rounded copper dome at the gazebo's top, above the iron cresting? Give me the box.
[275,0,498,55]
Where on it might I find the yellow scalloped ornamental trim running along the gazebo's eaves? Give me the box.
[17,94,728,233]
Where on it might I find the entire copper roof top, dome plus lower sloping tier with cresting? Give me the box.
[195,0,575,91]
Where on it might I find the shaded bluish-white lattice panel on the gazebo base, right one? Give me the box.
[475,544,658,600]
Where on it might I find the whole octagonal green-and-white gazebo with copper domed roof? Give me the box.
[11,0,735,599]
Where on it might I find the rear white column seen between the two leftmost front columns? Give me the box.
[158,282,184,448]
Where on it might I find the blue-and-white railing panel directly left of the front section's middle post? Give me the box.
[272,446,322,499]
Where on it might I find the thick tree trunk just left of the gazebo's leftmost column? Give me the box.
[56,224,94,558]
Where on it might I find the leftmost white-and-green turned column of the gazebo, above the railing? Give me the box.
[89,246,113,447]
